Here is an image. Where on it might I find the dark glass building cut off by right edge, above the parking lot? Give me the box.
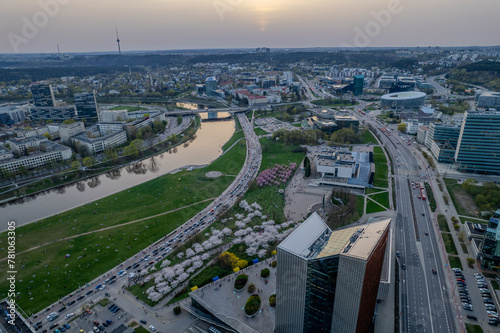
[481,209,500,271]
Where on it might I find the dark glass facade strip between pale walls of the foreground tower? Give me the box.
[304,255,339,333]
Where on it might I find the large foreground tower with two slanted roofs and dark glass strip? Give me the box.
[275,213,391,333]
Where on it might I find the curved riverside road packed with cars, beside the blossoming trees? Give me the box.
[34,114,262,332]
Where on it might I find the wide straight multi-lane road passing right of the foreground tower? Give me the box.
[356,106,458,333]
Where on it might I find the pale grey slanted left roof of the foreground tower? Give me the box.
[278,212,331,258]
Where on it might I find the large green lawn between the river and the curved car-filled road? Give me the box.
[0,141,246,313]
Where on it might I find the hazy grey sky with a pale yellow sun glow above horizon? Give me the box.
[0,0,500,53]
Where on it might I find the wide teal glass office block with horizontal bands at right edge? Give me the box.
[455,111,500,174]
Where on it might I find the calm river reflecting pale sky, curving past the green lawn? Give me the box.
[0,115,234,228]
